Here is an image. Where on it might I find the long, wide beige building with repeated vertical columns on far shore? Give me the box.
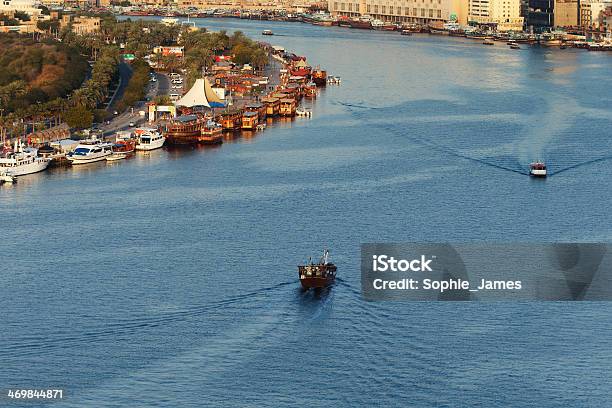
[328,0,467,24]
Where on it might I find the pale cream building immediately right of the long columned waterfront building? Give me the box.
[468,0,524,31]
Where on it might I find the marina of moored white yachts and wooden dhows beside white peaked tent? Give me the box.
[0,40,333,181]
